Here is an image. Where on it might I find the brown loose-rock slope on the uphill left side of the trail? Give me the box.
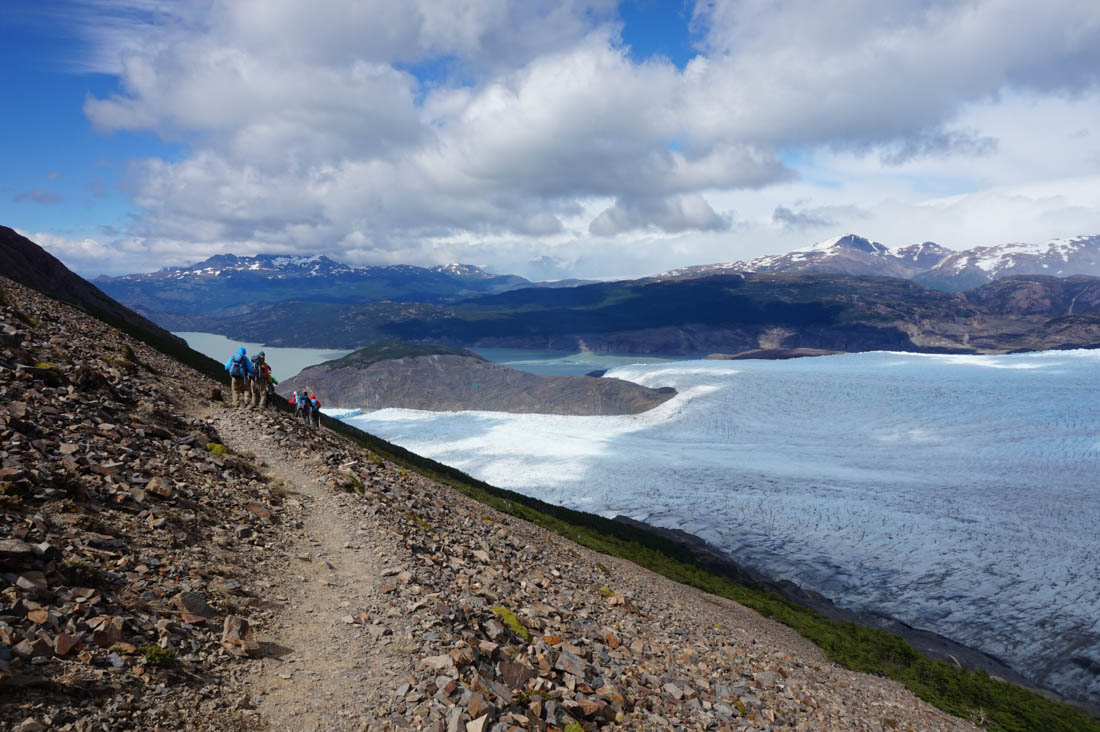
[0,278,283,731]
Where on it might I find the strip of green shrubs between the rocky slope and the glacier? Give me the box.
[314,417,1100,732]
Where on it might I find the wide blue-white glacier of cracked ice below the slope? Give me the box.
[332,351,1100,702]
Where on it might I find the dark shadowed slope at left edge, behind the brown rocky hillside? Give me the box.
[0,227,186,347]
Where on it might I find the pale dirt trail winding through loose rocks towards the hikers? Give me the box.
[209,409,411,731]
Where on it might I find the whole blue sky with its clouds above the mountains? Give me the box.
[0,0,1100,280]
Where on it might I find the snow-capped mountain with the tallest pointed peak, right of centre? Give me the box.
[659,233,952,278]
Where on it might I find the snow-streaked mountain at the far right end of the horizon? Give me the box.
[914,236,1100,291]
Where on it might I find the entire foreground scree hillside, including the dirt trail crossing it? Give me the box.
[0,246,1096,732]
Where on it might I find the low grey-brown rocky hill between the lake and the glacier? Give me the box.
[279,354,675,415]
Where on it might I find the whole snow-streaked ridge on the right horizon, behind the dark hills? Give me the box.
[652,234,1100,292]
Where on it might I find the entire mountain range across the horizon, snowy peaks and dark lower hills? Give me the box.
[23,228,1100,356]
